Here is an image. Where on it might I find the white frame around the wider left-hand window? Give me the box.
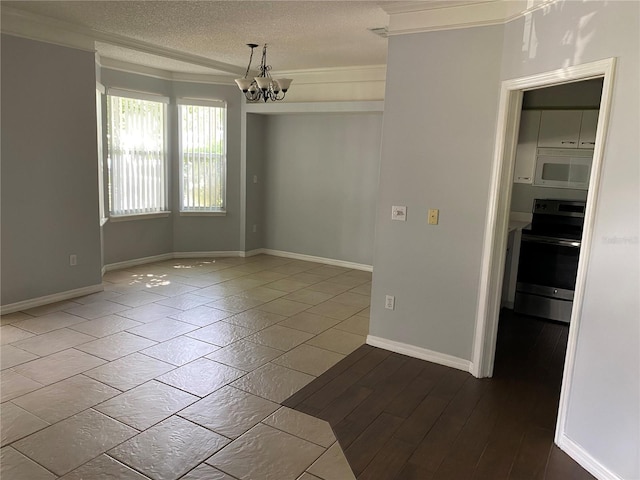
[107,88,170,221]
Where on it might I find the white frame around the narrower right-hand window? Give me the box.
[176,98,227,216]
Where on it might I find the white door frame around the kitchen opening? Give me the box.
[471,58,616,438]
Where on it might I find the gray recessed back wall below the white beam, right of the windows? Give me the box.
[264,113,382,265]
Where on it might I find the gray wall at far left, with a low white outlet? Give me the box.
[1,35,101,305]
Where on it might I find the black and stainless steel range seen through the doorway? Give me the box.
[514,199,585,322]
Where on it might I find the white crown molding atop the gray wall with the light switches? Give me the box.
[385,0,559,36]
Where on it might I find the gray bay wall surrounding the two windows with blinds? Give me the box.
[102,69,241,264]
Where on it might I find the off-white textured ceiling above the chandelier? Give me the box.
[2,1,388,73]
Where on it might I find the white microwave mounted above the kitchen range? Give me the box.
[533,148,593,190]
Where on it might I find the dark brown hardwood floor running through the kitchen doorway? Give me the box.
[284,310,593,480]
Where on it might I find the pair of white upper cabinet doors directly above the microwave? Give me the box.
[538,110,598,149]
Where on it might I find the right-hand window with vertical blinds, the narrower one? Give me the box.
[179,99,227,212]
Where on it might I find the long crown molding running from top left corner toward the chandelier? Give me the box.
[1,6,245,75]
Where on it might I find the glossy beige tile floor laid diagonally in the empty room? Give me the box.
[0,255,371,480]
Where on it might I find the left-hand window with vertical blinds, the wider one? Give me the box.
[107,90,168,216]
